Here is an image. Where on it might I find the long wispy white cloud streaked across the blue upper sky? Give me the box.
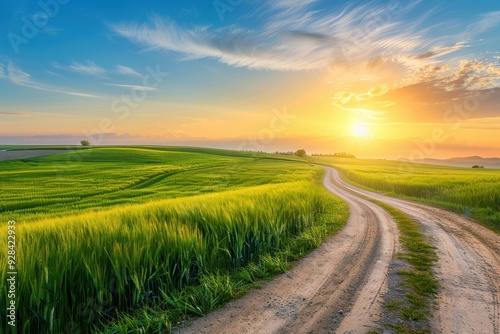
[110,0,500,80]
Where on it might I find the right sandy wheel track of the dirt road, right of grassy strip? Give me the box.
[334,172,500,334]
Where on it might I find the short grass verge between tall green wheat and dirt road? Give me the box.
[97,190,348,334]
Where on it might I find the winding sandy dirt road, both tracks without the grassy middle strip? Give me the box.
[174,167,500,334]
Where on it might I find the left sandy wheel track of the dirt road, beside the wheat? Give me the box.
[175,169,399,334]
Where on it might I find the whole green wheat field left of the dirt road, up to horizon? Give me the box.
[0,147,347,333]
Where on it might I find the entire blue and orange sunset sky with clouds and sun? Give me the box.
[0,0,500,159]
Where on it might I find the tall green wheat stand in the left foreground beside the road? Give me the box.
[0,181,344,333]
